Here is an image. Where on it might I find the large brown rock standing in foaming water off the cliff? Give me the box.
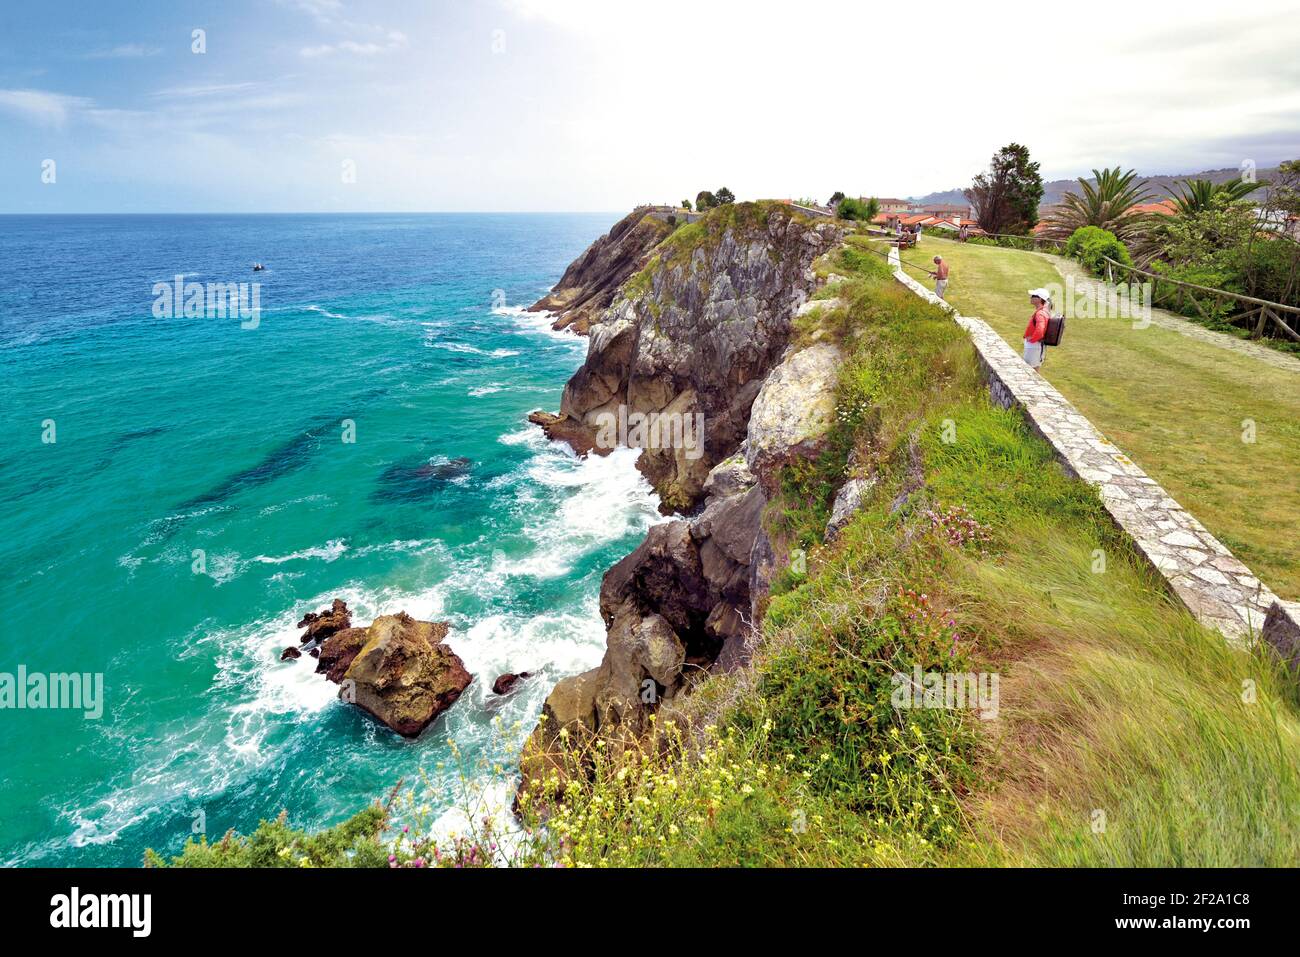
[316,611,472,737]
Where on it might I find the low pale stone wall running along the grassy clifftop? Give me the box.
[889,248,1300,650]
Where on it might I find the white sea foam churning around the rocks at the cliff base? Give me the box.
[44,289,663,846]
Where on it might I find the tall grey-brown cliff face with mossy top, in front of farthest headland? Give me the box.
[530,204,841,514]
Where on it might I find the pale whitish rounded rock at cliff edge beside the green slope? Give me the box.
[746,342,842,493]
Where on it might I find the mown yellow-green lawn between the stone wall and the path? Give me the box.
[902,235,1300,598]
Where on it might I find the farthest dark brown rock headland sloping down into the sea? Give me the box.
[529,207,672,333]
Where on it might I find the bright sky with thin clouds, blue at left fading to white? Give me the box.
[0,0,1300,213]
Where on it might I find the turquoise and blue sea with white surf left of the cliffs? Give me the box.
[0,215,658,865]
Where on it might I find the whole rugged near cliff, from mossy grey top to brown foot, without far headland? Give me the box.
[521,204,841,787]
